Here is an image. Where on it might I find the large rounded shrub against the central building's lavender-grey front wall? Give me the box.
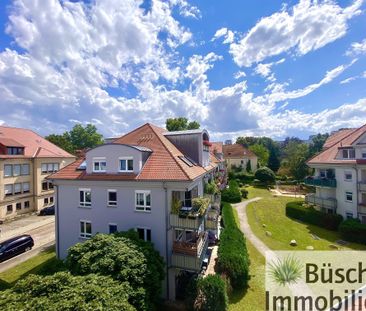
[66,232,164,310]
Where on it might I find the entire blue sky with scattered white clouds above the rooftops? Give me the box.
[0,0,366,139]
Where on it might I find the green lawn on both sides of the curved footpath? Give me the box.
[229,187,366,311]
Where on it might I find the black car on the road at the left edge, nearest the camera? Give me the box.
[0,234,34,262]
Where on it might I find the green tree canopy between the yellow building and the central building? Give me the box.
[45,124,103,154]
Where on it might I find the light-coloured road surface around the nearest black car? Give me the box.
[0,222,55,272]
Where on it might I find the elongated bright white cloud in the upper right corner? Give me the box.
[230,0,363,67]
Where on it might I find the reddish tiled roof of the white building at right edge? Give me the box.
[307,125,366,164]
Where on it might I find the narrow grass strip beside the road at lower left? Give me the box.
[0,248,64,290]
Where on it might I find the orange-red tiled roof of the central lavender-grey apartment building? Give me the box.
[50,123,217,181]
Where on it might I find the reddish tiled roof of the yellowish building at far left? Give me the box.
[0,126,74,158]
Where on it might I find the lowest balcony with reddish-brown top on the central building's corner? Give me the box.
[172,232,208,272]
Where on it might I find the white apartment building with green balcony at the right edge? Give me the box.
[305,125,366,223]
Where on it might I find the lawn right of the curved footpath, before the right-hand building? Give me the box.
[247,187,366,250]
